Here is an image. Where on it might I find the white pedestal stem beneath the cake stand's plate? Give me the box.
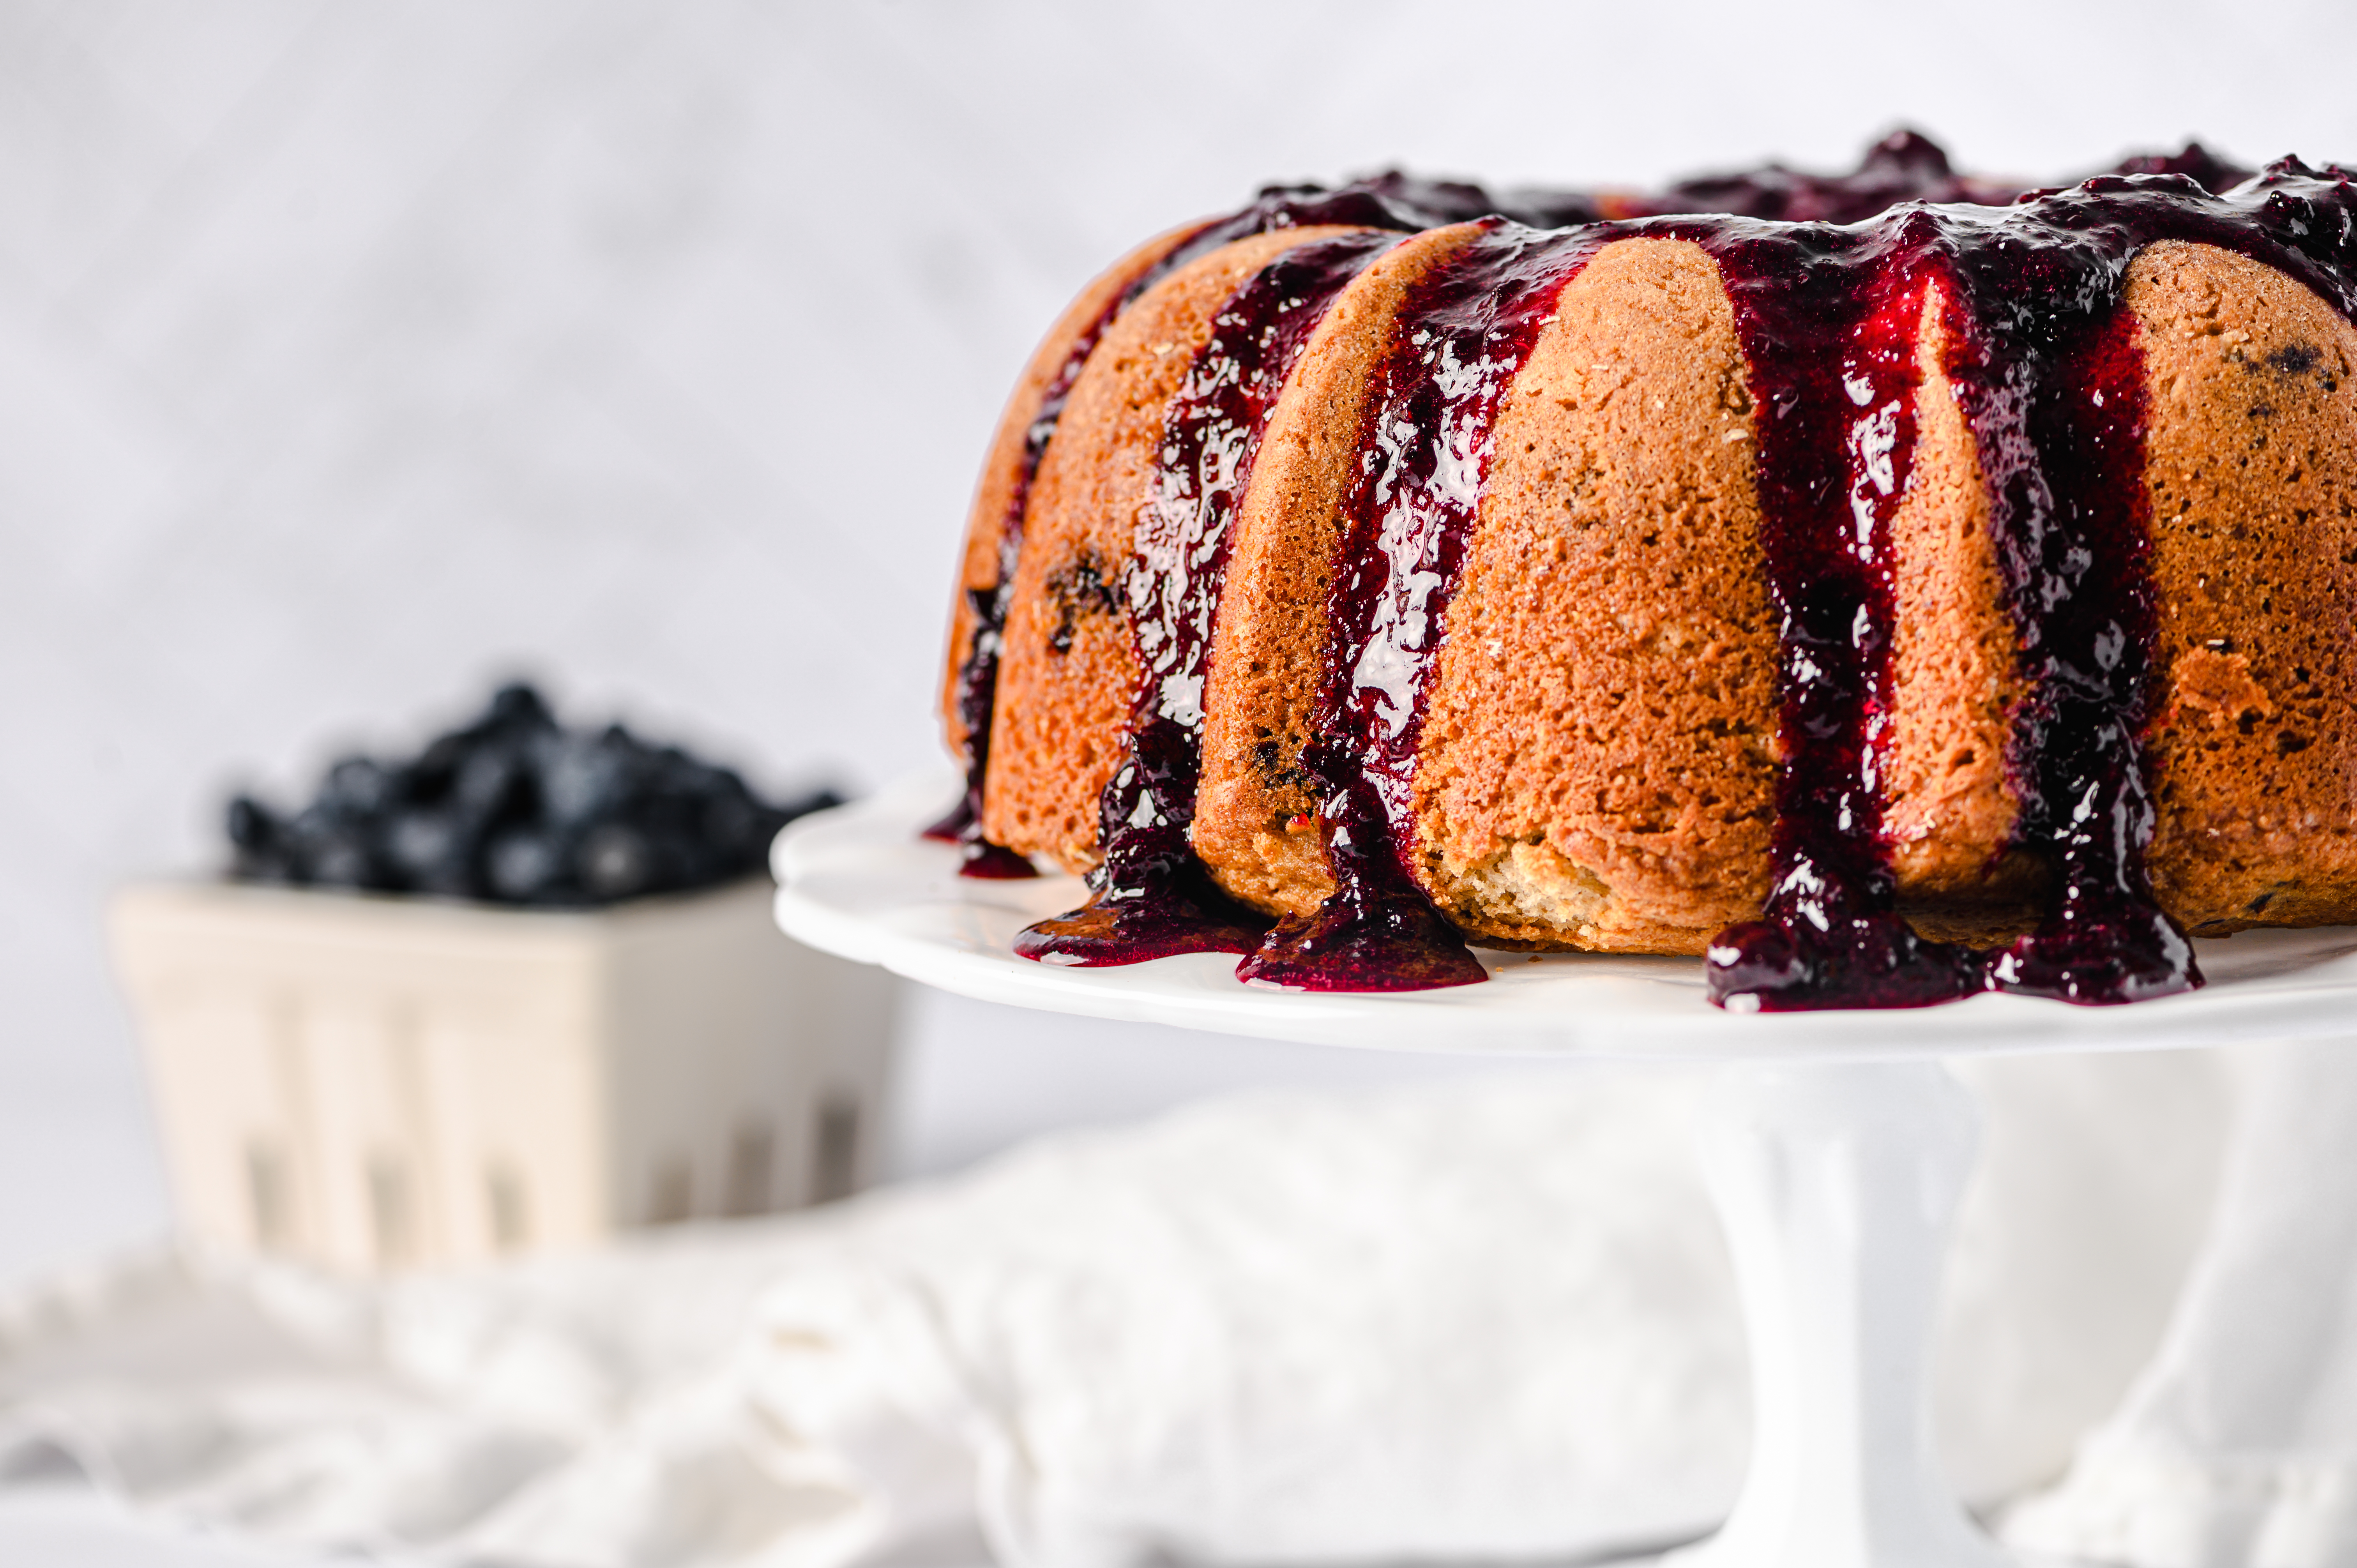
[1664,1061,2011,1568]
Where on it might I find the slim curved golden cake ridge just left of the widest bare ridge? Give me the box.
[1193,224,1480,915]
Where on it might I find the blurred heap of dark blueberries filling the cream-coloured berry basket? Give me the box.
[229,686,839,908]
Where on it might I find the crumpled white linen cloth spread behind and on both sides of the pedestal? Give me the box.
[0,1056,2223,1568]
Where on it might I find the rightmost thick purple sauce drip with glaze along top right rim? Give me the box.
[1947,168,2357,1002]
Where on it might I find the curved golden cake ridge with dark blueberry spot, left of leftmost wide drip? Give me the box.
[983,226,1355,872]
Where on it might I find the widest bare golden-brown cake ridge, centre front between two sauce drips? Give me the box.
[1414,238,1777,953]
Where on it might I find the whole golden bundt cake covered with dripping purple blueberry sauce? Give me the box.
[933,132,2357,1009]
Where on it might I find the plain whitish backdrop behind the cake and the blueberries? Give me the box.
[0,0,2357,1547]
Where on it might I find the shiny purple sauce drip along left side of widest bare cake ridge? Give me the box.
[1237,222,1603,990]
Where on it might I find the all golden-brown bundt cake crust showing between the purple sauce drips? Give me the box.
[950,196,2357,971]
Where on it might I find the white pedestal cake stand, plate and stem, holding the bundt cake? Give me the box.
[773,776,2357,1568]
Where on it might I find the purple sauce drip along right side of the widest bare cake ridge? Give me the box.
[1664,212,1980,1009]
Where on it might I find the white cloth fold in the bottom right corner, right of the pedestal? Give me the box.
[2006,1042,2357,1568]
